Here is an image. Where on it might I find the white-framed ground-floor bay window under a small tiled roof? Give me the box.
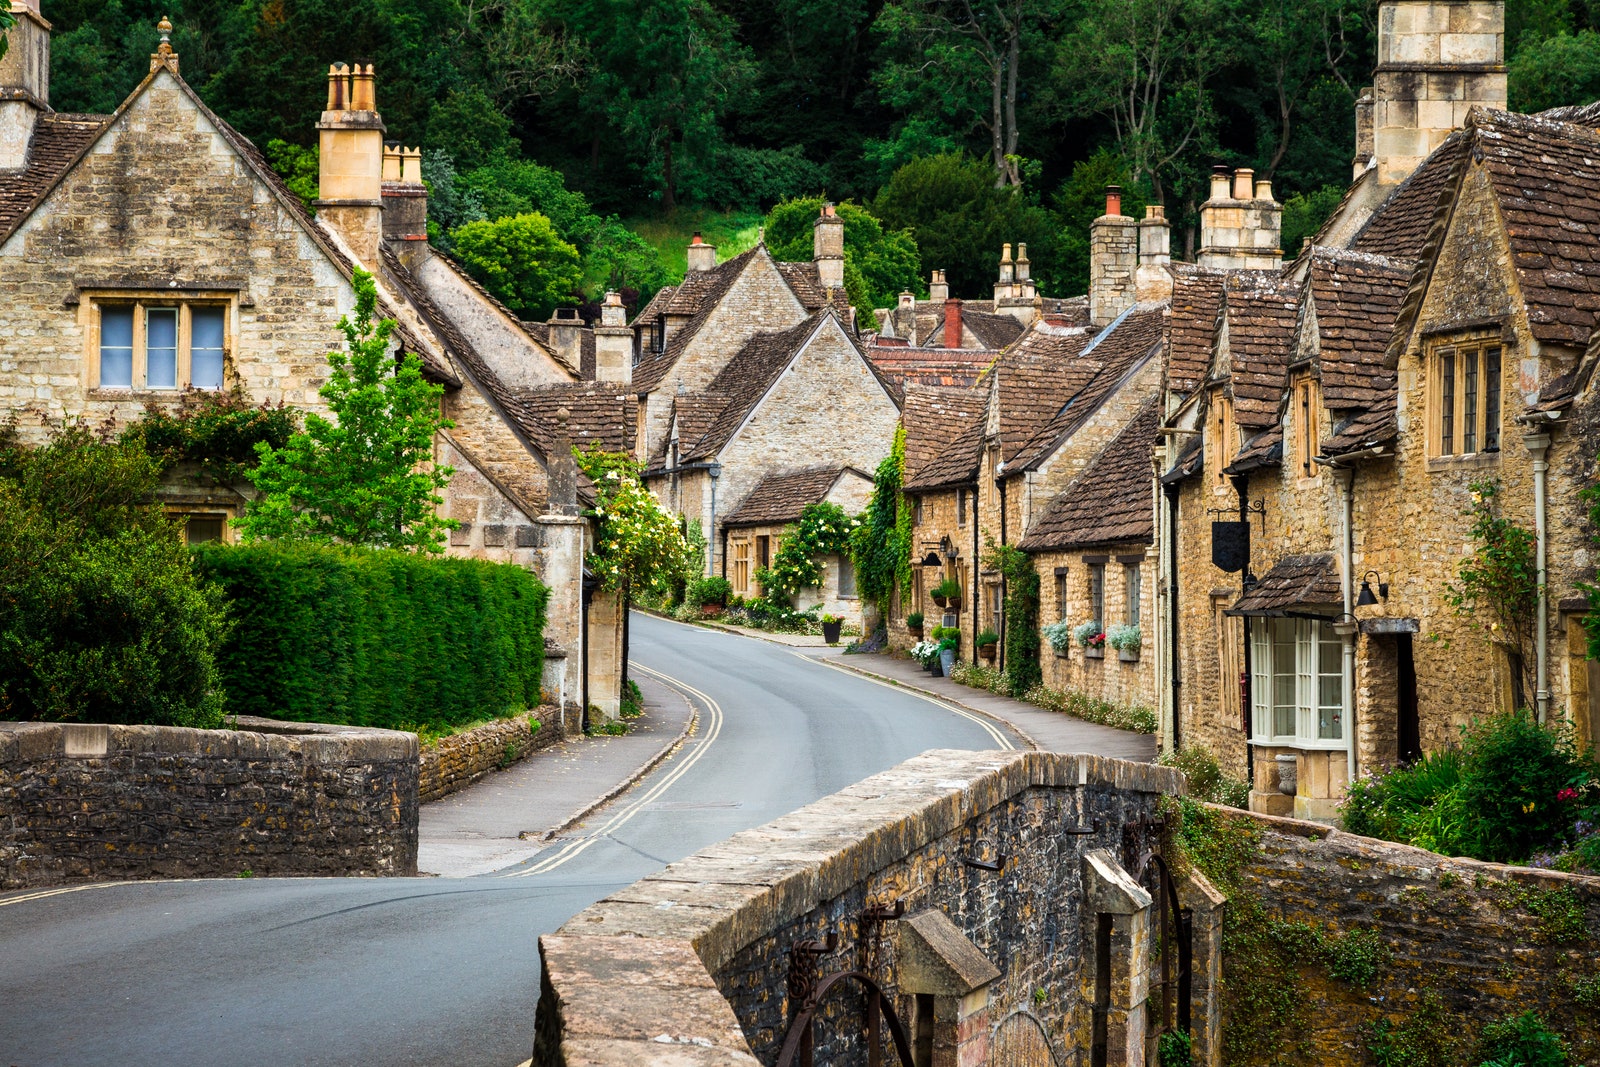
[1250,617,1346,750]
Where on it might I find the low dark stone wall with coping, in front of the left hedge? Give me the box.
[0,717,418,889]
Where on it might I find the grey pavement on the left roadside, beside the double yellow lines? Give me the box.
[418,673,694,878]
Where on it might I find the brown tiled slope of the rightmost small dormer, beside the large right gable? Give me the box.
[1307,248,1411,411]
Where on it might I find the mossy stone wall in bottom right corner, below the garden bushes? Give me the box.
[1213,808,1600,1067]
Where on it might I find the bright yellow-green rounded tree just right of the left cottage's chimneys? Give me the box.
[450,211,581,320]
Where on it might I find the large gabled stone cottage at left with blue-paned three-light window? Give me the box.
[0,0,634,712]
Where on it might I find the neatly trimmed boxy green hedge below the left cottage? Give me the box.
[195,542,549,728]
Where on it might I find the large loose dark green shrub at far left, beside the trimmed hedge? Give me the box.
[0,429,227,726]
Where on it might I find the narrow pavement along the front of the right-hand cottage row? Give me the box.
[805,646,1157,763]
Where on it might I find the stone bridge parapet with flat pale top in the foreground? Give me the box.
[534,752,1218,1067]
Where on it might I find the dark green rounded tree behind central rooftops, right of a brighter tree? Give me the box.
[876,155,1061,294]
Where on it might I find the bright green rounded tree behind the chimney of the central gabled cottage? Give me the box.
[766,197,922,323]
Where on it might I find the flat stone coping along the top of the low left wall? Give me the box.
[0,715,419,765]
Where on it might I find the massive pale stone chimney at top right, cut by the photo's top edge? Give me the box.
[1357,0,1506,186]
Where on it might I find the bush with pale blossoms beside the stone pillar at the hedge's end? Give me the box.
[573,448,702,593]
